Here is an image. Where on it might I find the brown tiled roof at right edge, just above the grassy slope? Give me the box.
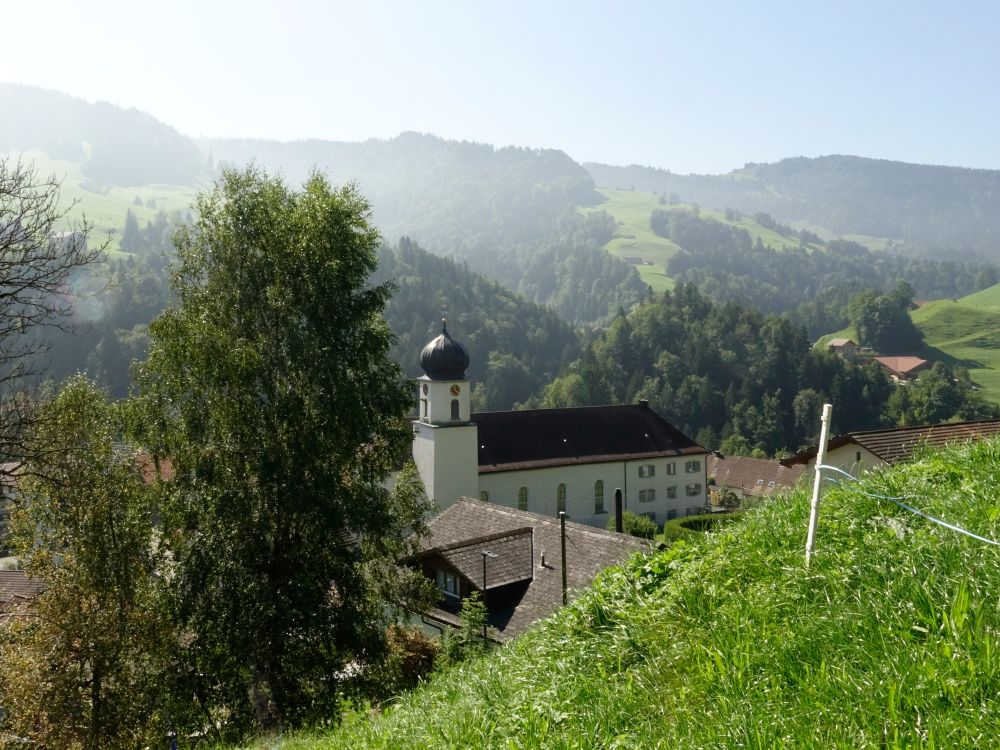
[781,419,1000,466]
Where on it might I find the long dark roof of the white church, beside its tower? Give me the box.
[472,404,707,474]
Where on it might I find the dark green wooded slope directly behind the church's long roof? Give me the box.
[531,284,998,455]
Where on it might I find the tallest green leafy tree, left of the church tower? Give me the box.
[129,168,425,731]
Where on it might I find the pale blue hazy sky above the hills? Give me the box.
[0,0,1000,174]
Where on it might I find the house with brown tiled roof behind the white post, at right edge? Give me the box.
[781,419,1000,473]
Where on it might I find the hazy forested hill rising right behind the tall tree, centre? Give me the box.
[201,133,646,323]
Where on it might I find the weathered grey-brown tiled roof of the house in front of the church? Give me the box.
[420,498,649,641]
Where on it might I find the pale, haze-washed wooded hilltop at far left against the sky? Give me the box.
[0,83,208,187]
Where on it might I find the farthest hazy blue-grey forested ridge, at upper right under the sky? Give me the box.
[584,156,1000,260]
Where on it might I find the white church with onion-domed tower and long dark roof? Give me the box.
[413,324,710,528]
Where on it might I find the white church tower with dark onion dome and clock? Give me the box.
[413,321,479,508]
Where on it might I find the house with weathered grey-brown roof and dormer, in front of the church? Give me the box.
[418,498,650,643]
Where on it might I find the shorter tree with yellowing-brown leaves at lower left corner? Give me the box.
[0,379,162,749]
